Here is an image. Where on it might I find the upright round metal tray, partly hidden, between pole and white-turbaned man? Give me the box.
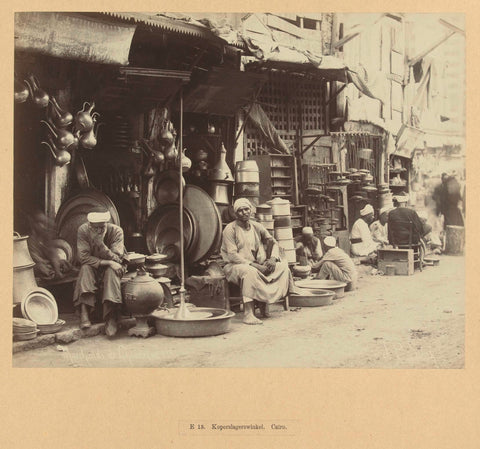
[183,185,222,263]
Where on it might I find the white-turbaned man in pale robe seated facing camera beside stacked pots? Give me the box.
[221,198,300,324]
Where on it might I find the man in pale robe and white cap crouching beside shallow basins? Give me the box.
[317,237,357,291]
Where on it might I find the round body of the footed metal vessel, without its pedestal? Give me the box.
[123,270,164,316]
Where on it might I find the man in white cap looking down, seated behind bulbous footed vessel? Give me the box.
[73,212,126,337]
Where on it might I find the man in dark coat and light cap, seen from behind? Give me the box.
[388,192,432,246]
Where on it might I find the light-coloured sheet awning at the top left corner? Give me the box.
[14,12,135,65]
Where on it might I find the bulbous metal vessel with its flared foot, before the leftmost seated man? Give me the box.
[123,270,165,338]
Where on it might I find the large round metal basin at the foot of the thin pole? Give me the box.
[152,307,235,337]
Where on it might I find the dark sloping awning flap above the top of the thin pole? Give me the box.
[184,68,267,116]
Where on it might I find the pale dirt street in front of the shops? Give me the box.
[13,256,465,368]
